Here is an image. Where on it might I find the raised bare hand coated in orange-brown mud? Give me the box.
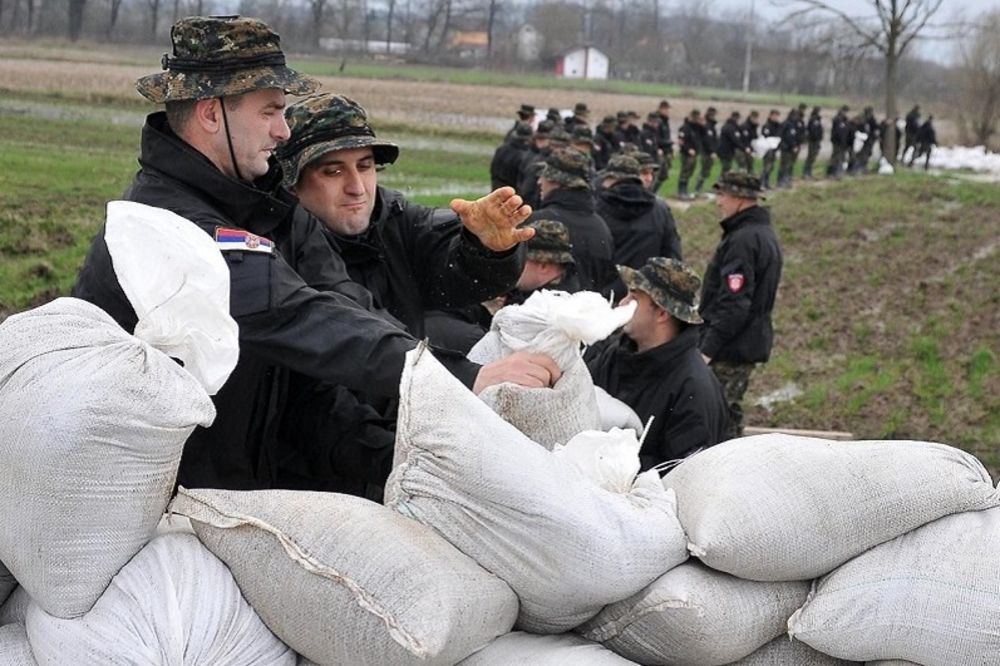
[451,187,535,252]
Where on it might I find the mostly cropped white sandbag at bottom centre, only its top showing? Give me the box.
[458,631,635,666]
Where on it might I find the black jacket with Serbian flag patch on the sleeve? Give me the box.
[73,112,479,489]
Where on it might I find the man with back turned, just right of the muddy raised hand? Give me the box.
[528,148,614,293]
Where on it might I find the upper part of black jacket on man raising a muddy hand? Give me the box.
[324,187,524,338]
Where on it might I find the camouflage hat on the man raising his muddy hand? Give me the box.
[277,93,399,187]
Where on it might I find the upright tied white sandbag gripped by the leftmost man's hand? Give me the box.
[469,290,638,449]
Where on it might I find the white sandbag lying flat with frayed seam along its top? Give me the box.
[171,482,516,666]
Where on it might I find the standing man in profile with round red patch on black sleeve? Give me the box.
[699,172,783,437]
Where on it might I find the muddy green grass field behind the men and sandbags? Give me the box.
[0,48,1000,474]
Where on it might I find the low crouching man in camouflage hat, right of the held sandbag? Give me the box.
[586,257,729,469]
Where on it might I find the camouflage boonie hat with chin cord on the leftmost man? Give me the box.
[135,16,319,104]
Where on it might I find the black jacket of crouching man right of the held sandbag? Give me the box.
[586,327,729,470]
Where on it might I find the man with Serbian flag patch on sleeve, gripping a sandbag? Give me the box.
[73,16,558,496]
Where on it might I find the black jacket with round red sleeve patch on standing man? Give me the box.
[699,206,782,363]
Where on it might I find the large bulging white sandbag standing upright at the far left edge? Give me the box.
[0,298,215,617]
